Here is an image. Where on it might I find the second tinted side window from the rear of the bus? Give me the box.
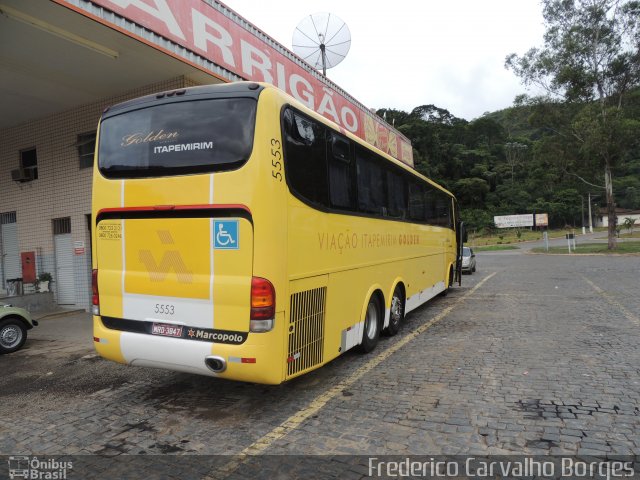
[328,133,356,211]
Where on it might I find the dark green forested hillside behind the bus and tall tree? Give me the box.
[377,89,640,234]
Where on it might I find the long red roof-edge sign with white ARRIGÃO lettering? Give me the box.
[67,0,413,165]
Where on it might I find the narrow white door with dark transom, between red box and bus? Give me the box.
[53,217,76,305]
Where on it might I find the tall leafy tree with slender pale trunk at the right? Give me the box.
[506,0,640,249]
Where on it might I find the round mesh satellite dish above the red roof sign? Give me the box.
[293,13,351,76]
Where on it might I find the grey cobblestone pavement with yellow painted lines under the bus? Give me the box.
[0,251,640,478]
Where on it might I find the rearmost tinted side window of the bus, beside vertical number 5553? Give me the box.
[283,110,329,207]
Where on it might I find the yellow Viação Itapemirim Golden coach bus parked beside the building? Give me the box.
[92,82,462,384]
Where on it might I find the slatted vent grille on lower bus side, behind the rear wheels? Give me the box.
[287,287,327,376]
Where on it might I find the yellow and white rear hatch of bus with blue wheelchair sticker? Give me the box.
[97,216,253,338]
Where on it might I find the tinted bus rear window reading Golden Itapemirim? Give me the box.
[98,98,256,178]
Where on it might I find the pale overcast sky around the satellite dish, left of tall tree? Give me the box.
[222,0,544,120]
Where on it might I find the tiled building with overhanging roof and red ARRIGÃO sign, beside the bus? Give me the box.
[0,0,413,309]
